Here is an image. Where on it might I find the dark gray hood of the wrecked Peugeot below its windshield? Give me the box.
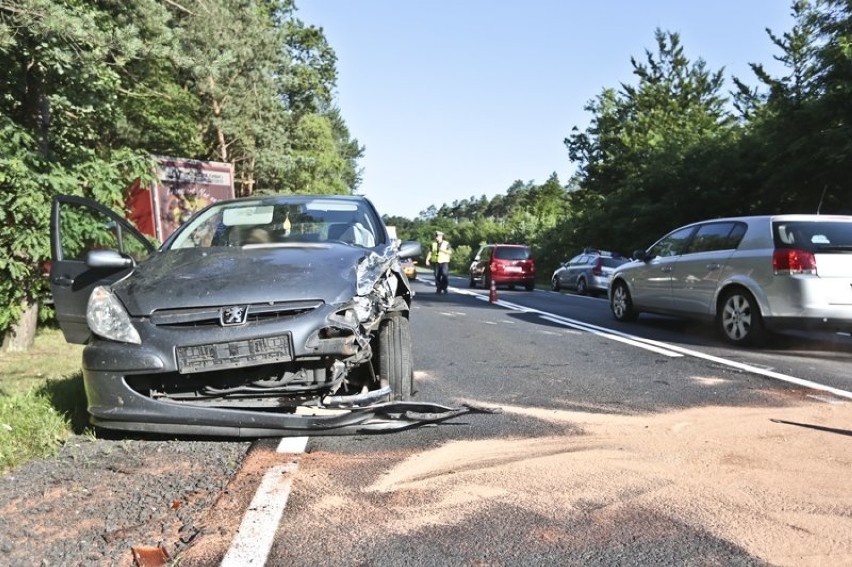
[113,244,380,316]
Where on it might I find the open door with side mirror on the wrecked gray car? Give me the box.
[50,195,156,344]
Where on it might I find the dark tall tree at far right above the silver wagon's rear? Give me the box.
[734,1,849,213]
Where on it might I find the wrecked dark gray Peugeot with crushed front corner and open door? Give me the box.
[50,195,487,437]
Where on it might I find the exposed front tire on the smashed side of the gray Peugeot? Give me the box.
[378,315,415,400]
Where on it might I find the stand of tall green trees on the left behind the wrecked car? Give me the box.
[0,0,364,350]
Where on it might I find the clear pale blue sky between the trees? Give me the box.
[296,0,793,219]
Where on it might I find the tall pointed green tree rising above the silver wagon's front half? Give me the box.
[565,30,737,250]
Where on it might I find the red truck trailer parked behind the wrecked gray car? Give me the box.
[127,157,234,242]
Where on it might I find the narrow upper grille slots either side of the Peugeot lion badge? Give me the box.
[146,300,323,327]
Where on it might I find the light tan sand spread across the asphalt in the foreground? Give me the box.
[360,401,852,565]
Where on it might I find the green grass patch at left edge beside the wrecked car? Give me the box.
[0,329,88,474]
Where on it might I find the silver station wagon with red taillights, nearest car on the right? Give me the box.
[609,215,852,346]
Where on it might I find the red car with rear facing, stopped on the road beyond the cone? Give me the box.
[470,244,535,291]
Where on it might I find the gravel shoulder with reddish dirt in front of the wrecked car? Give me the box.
[0,436,250,566]
